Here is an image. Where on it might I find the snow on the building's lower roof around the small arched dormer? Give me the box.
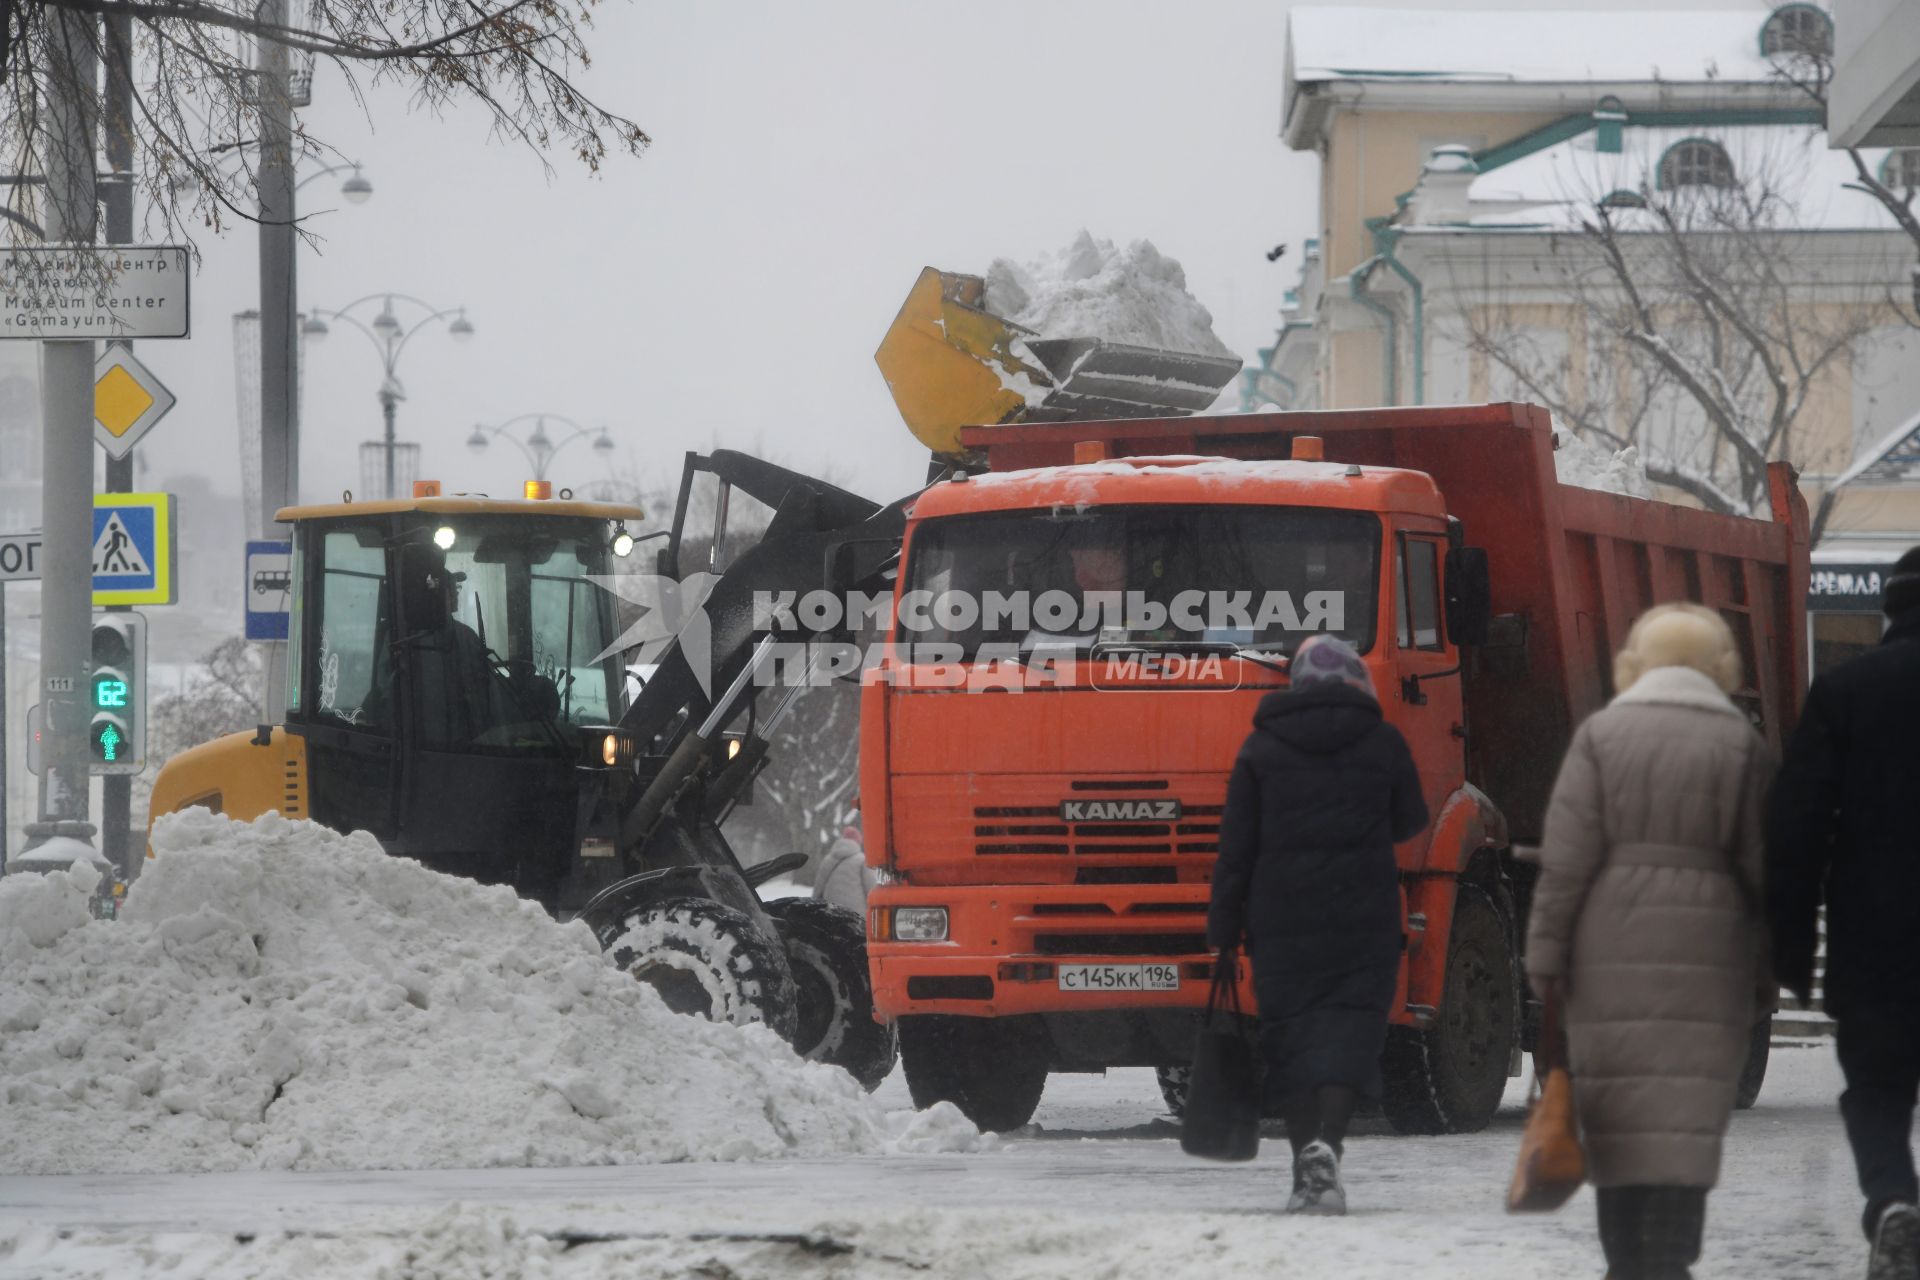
[1436,125,1893,230]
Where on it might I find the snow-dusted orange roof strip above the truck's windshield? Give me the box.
[912,455,1446,520]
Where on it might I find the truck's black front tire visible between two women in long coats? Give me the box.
[1380,885,1521,1134]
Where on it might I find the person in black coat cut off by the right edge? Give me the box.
[1766,547,1920,1280]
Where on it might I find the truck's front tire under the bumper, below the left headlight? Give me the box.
[899,1013,1046,1132]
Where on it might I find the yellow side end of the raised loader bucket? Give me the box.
[874,267,1052,457]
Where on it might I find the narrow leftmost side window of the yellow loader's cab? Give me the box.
[311,530,394,733]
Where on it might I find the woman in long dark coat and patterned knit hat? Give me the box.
[1208,635,1427,1213]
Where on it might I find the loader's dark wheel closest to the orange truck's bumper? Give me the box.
[766,898,900,1092]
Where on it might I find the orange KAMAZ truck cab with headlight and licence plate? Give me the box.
[862,441,1513,1126]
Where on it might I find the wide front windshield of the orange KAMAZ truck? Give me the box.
[895,505,1380,658]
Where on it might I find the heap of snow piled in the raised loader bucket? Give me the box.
[987,230,1233,355]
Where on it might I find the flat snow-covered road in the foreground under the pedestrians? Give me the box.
[0,1048,1864,1280]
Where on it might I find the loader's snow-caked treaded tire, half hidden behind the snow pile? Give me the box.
[601,898,797,1040]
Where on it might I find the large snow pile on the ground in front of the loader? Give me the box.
[0,810,981,1174]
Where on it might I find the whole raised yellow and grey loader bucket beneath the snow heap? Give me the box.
[874,267,1240,459]
